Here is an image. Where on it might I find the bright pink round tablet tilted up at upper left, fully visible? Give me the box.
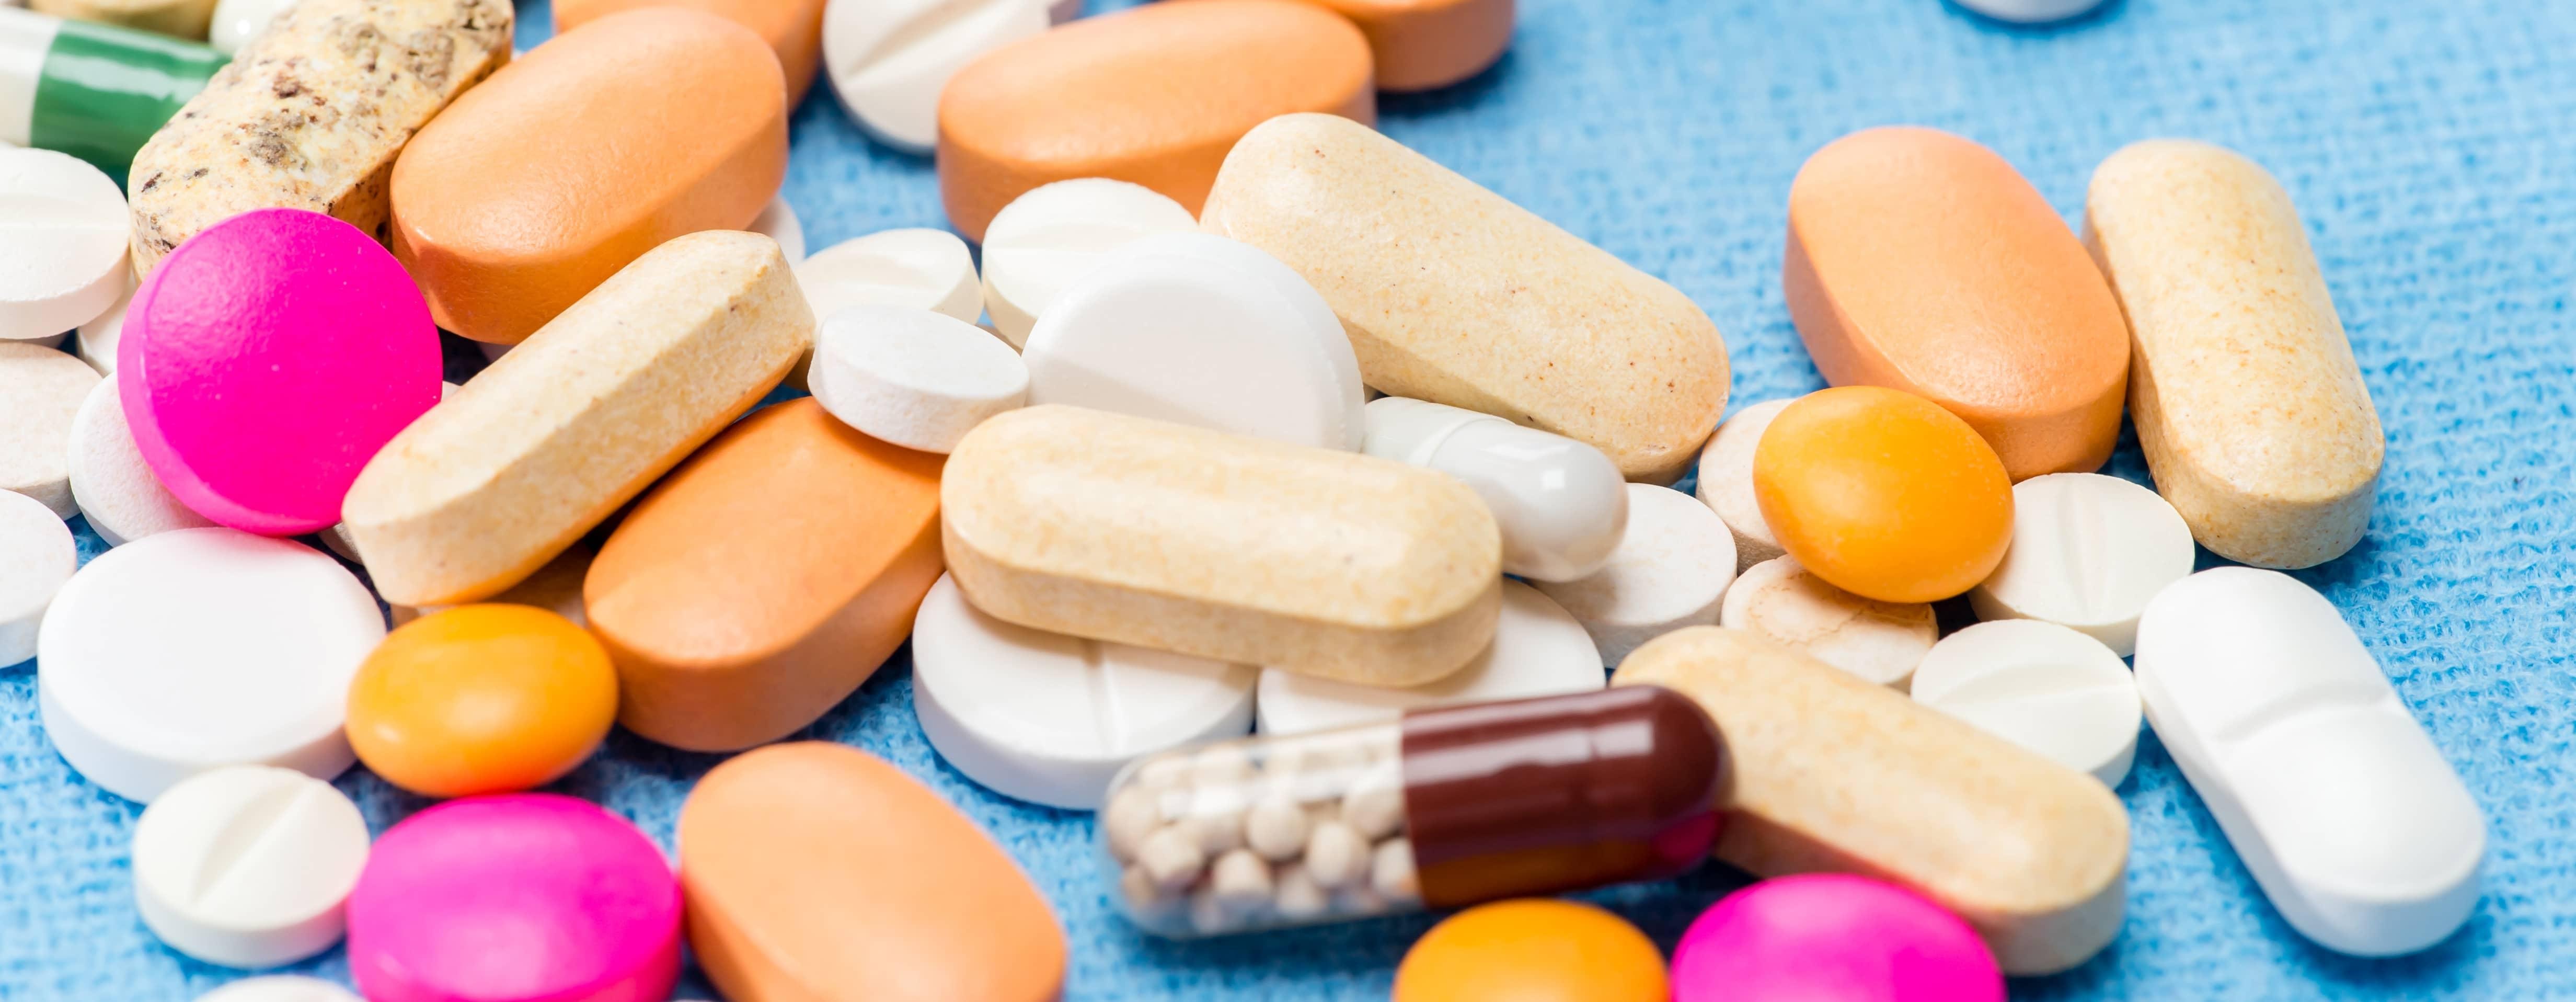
[116,209,441,536]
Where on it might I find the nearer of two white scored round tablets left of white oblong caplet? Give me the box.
[1914,618,2138,785]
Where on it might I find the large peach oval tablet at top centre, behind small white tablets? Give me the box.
[938,0,1378,242]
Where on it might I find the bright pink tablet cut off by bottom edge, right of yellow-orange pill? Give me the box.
[1672,873,2004,1002]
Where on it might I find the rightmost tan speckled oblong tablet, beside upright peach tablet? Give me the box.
[2084,139,2385,567]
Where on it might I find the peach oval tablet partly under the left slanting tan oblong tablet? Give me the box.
[582,397,946,752]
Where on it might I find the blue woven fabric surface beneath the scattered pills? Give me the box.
[0,0,2576,999]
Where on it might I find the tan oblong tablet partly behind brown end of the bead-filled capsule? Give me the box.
[1610,626,2128,974]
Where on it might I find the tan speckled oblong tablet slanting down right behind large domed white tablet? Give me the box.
[1200,113,1726,484]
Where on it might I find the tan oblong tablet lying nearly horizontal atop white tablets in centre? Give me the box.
[940,404,1502,685]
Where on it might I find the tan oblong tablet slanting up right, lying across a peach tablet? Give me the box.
[342,232,814,605]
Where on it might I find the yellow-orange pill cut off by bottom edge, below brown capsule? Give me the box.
[1394,899,1666,1002]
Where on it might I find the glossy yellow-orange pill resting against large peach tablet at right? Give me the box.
[1754,386,2012,603]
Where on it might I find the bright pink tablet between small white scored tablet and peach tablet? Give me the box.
[348,793,680,1002]
